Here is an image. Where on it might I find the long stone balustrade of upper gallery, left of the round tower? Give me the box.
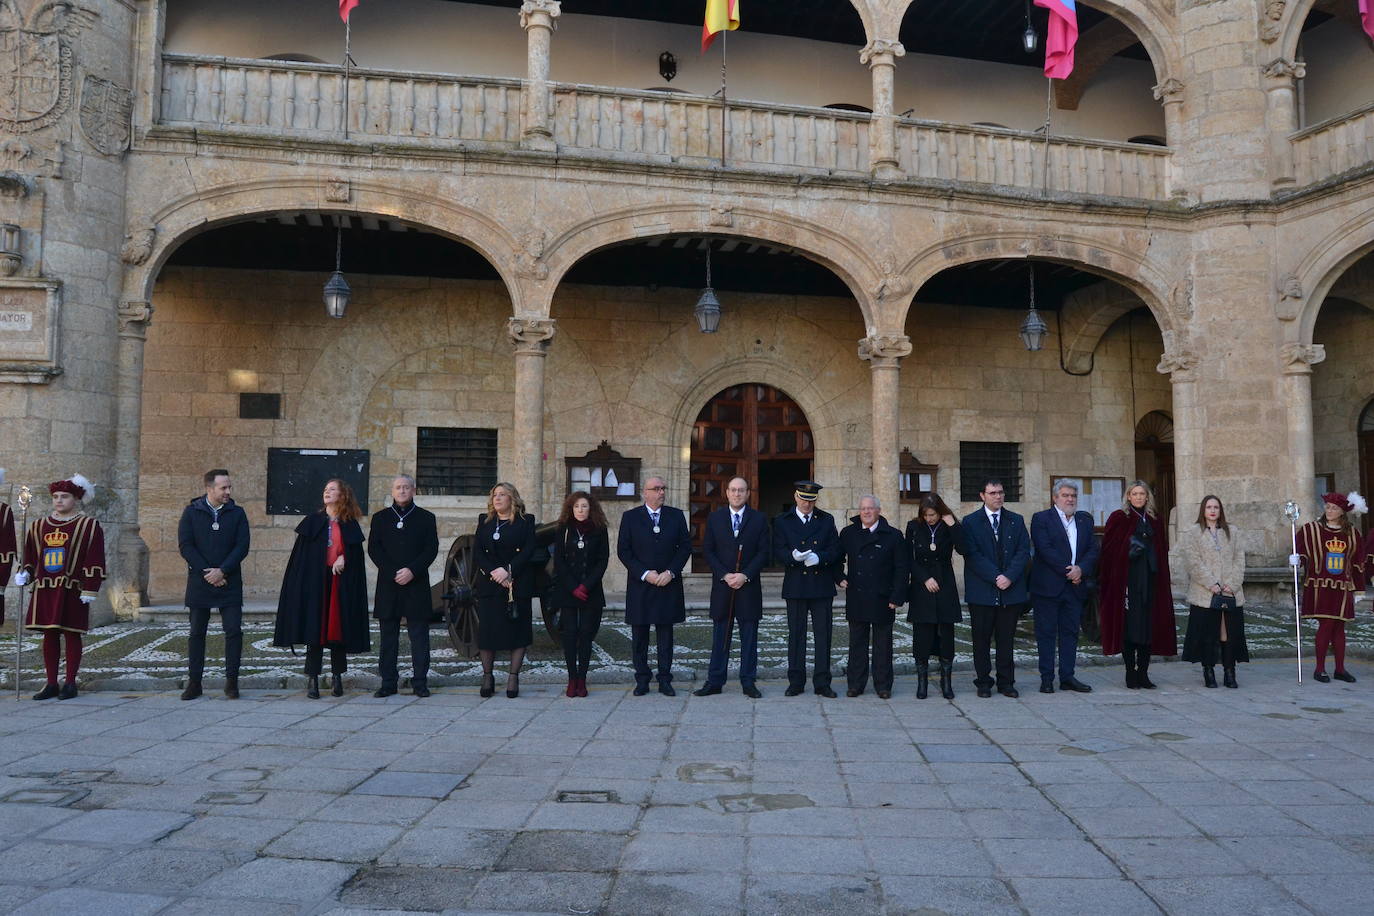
[159,54,1169,201]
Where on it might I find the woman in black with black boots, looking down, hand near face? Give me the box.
[907,493,965,700]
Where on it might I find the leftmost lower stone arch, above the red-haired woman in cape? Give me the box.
[124,176,521,313]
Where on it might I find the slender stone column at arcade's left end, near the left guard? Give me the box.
[107,301,153,614]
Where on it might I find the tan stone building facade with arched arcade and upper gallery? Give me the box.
[0,0,1374,612]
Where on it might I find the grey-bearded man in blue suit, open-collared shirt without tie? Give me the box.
[1031,481,1098,694]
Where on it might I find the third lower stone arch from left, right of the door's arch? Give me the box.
[900,232,1186,346]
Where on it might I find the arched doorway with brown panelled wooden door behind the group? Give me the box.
[688,383,815,554]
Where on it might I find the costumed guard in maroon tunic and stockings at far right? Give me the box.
[1289,493,1367,684]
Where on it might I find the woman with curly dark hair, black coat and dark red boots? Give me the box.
[552,490,610,696]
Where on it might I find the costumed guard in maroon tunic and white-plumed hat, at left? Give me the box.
[15,474,104,700]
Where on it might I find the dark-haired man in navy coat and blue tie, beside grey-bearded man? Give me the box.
[963,478,1031,699]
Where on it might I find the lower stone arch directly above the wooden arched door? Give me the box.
[528,203,892,334]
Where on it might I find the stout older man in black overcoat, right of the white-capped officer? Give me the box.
[835,494,911,699]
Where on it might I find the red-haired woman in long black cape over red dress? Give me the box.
[272,479,372,699]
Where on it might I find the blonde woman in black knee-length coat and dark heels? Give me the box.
[473,483,536,699]
